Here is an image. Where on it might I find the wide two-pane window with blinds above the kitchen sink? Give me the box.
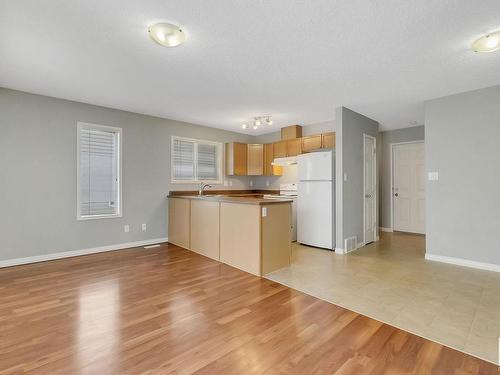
[172,137,222,184]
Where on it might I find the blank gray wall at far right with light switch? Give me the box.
[425,86,500,265]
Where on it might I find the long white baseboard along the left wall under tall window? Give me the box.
[0,237,168,268]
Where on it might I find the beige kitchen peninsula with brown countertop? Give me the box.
[168,192,292,276]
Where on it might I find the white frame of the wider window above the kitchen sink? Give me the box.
[170,135,224,185]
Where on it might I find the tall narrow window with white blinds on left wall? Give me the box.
[77,122,122,220]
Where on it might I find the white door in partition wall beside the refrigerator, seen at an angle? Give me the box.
[363,134,377,244]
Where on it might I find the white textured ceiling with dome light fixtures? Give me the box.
[0,0,500,134]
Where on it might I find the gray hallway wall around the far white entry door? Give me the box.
[379,125,425,228]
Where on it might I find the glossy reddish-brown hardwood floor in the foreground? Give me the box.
[0,244,497,374]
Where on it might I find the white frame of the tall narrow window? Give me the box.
[76,121,123,221]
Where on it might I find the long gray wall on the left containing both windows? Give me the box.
[0,88,253,260]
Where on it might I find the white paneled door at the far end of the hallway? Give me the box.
[392,142,425,234]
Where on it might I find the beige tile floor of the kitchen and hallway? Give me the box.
[266,233,500,364]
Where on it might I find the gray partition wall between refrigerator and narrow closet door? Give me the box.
[335,107,378,248]
